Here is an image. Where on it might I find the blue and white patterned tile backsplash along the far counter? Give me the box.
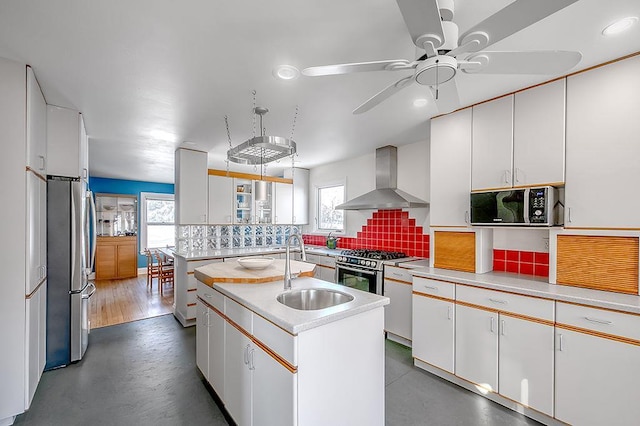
[176,225,298,253]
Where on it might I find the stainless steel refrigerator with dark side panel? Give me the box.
[45,176,96,370]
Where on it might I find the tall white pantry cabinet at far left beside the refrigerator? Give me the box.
[0,58,47,424]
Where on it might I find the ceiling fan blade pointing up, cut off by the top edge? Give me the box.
[396,0,444,50]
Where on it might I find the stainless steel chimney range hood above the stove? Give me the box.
[335,145,429,210]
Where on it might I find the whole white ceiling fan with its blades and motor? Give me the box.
[302,0,582,114]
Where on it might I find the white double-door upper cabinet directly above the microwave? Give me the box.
[471,79,566,190]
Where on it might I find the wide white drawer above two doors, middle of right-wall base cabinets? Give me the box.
[456,285,554,321]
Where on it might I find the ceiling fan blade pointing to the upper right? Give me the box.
[456,0,578,56]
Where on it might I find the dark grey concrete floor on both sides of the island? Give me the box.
[14,315,538,426]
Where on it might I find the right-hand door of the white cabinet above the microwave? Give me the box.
[513,78,566,186]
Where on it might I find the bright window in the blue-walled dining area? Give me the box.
[140,192,176,250]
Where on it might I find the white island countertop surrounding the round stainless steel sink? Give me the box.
[213,277,389,335]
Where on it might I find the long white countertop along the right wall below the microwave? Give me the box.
[411,267,640,314]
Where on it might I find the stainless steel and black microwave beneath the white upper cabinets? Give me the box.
[471,186,562,226]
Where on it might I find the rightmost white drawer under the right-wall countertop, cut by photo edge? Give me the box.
[556,302,640,341]
